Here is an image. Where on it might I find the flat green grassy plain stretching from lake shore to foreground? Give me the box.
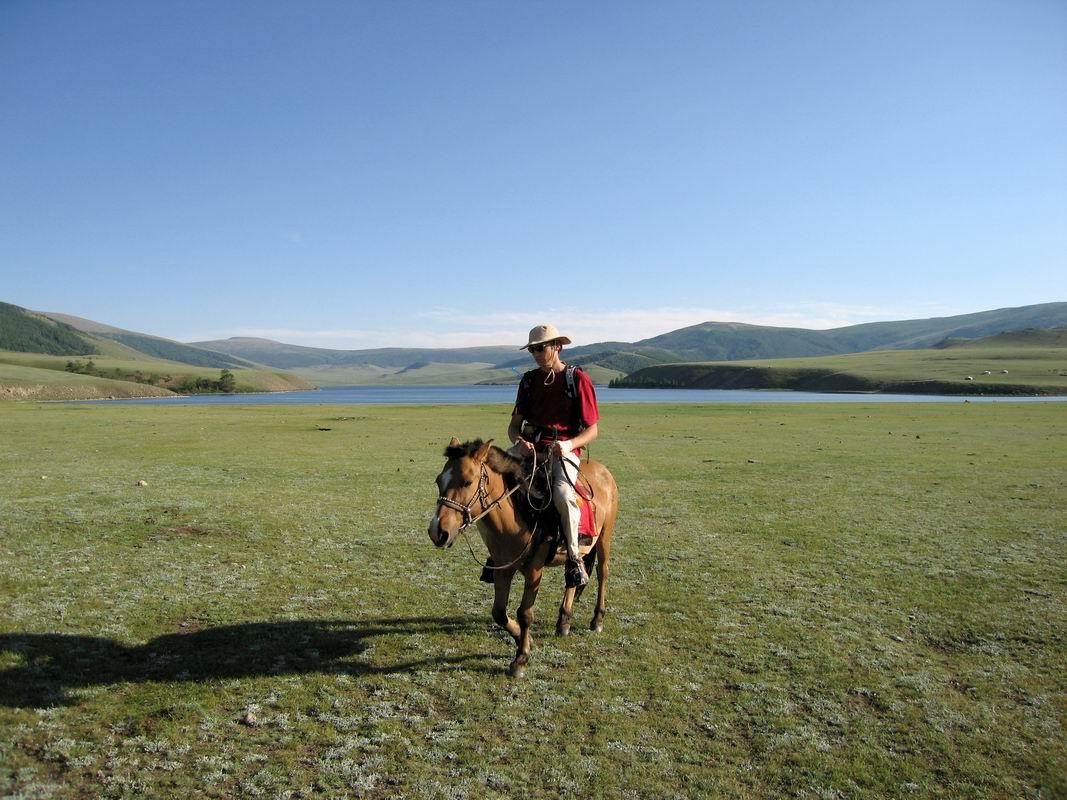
[0,402,1067,798]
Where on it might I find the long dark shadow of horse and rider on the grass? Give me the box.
[0,617,499,708]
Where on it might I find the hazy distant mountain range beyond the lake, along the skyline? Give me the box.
[0,303,1067,384]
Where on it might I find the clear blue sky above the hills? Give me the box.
[0,0,1067,349]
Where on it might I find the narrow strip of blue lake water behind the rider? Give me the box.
[66,386,1067,405]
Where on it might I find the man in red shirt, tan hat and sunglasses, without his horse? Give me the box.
[508,325,600,587]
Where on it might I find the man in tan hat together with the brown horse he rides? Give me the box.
[427,325,619,677]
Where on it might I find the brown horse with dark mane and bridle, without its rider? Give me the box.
[428,438,619,677]
